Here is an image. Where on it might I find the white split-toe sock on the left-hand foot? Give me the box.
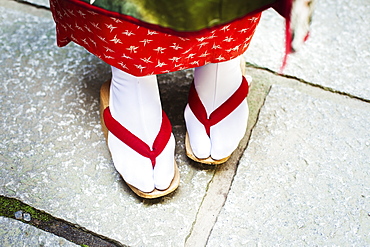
[108,67,175,192]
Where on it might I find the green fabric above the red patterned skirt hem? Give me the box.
[82,0,276,31]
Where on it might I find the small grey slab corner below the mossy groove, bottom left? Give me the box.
[0,216,79,247]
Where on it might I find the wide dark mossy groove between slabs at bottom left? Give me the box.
[0,195,125,247]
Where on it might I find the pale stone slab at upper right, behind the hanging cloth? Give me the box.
[246,0,370,100]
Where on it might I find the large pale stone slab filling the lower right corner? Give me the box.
[207,85,370,246]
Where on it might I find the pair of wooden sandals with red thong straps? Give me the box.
[100,69,249,199]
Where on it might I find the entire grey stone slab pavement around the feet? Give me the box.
[0,0,370,246]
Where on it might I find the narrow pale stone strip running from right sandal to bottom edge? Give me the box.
[185,68,271,247]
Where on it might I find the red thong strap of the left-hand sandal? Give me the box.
[103,107,172,168]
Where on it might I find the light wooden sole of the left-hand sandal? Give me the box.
[100,80,180,199]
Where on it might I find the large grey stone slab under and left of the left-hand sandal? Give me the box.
[0,4,214,246]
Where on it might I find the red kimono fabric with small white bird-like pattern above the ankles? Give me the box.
[50,0,261,76]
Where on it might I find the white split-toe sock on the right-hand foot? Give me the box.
[184,57,249,160]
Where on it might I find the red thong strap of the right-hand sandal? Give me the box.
[188,76,249,136]
